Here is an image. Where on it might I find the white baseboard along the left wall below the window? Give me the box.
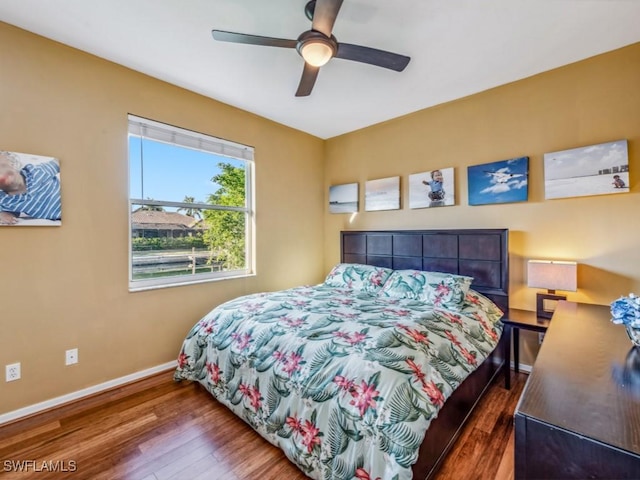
[0,360,178,426]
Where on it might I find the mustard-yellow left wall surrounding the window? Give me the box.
[0,23,326,414]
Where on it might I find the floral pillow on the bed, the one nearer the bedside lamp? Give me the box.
[379,270,473,308]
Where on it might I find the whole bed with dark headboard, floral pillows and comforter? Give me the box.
[174,229,508,480]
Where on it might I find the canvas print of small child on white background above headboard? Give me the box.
[409,168,455,208]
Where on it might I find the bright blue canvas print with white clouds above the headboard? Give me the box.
[467,157,529,205]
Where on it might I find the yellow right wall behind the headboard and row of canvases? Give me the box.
[324,44,640,363]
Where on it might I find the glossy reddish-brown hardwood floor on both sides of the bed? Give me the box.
[0,371,527,480]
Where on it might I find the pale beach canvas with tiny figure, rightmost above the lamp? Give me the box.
[544,140,629,199]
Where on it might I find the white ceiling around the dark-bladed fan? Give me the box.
[0,0,640,139]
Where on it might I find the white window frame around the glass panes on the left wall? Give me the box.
[127,114,255,292]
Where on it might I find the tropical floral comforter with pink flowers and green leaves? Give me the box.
[175,284,502,480]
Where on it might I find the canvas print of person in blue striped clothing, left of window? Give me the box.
[0,150,62,226]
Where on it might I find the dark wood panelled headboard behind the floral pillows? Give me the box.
[340,229,509,312]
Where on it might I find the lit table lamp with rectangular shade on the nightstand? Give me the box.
[527,260,578,318]
